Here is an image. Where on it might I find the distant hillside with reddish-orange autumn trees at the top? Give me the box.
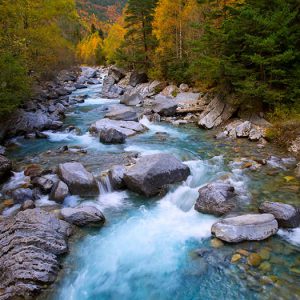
[76,0,127,21]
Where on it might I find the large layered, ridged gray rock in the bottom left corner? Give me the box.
[0,208,71,300]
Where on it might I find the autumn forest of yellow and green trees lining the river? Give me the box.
[0,0,300,119]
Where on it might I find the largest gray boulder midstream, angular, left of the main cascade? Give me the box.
[124,154,190,197]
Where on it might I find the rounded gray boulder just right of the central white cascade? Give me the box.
[195,181,235,216]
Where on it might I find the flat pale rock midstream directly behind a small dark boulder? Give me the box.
[90,118,147,137]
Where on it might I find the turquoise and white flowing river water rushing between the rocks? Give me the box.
[6,80,300,300]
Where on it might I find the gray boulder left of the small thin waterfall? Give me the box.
[58,162,99,196]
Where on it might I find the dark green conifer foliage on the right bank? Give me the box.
[191,0,300,106]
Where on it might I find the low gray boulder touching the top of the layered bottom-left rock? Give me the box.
[61,206,105,227]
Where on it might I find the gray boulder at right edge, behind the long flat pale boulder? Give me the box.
[259,201,300,228]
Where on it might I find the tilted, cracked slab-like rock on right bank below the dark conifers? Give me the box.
[198,97,236,129]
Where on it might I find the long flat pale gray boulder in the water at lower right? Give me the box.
[211,214,278,243]
